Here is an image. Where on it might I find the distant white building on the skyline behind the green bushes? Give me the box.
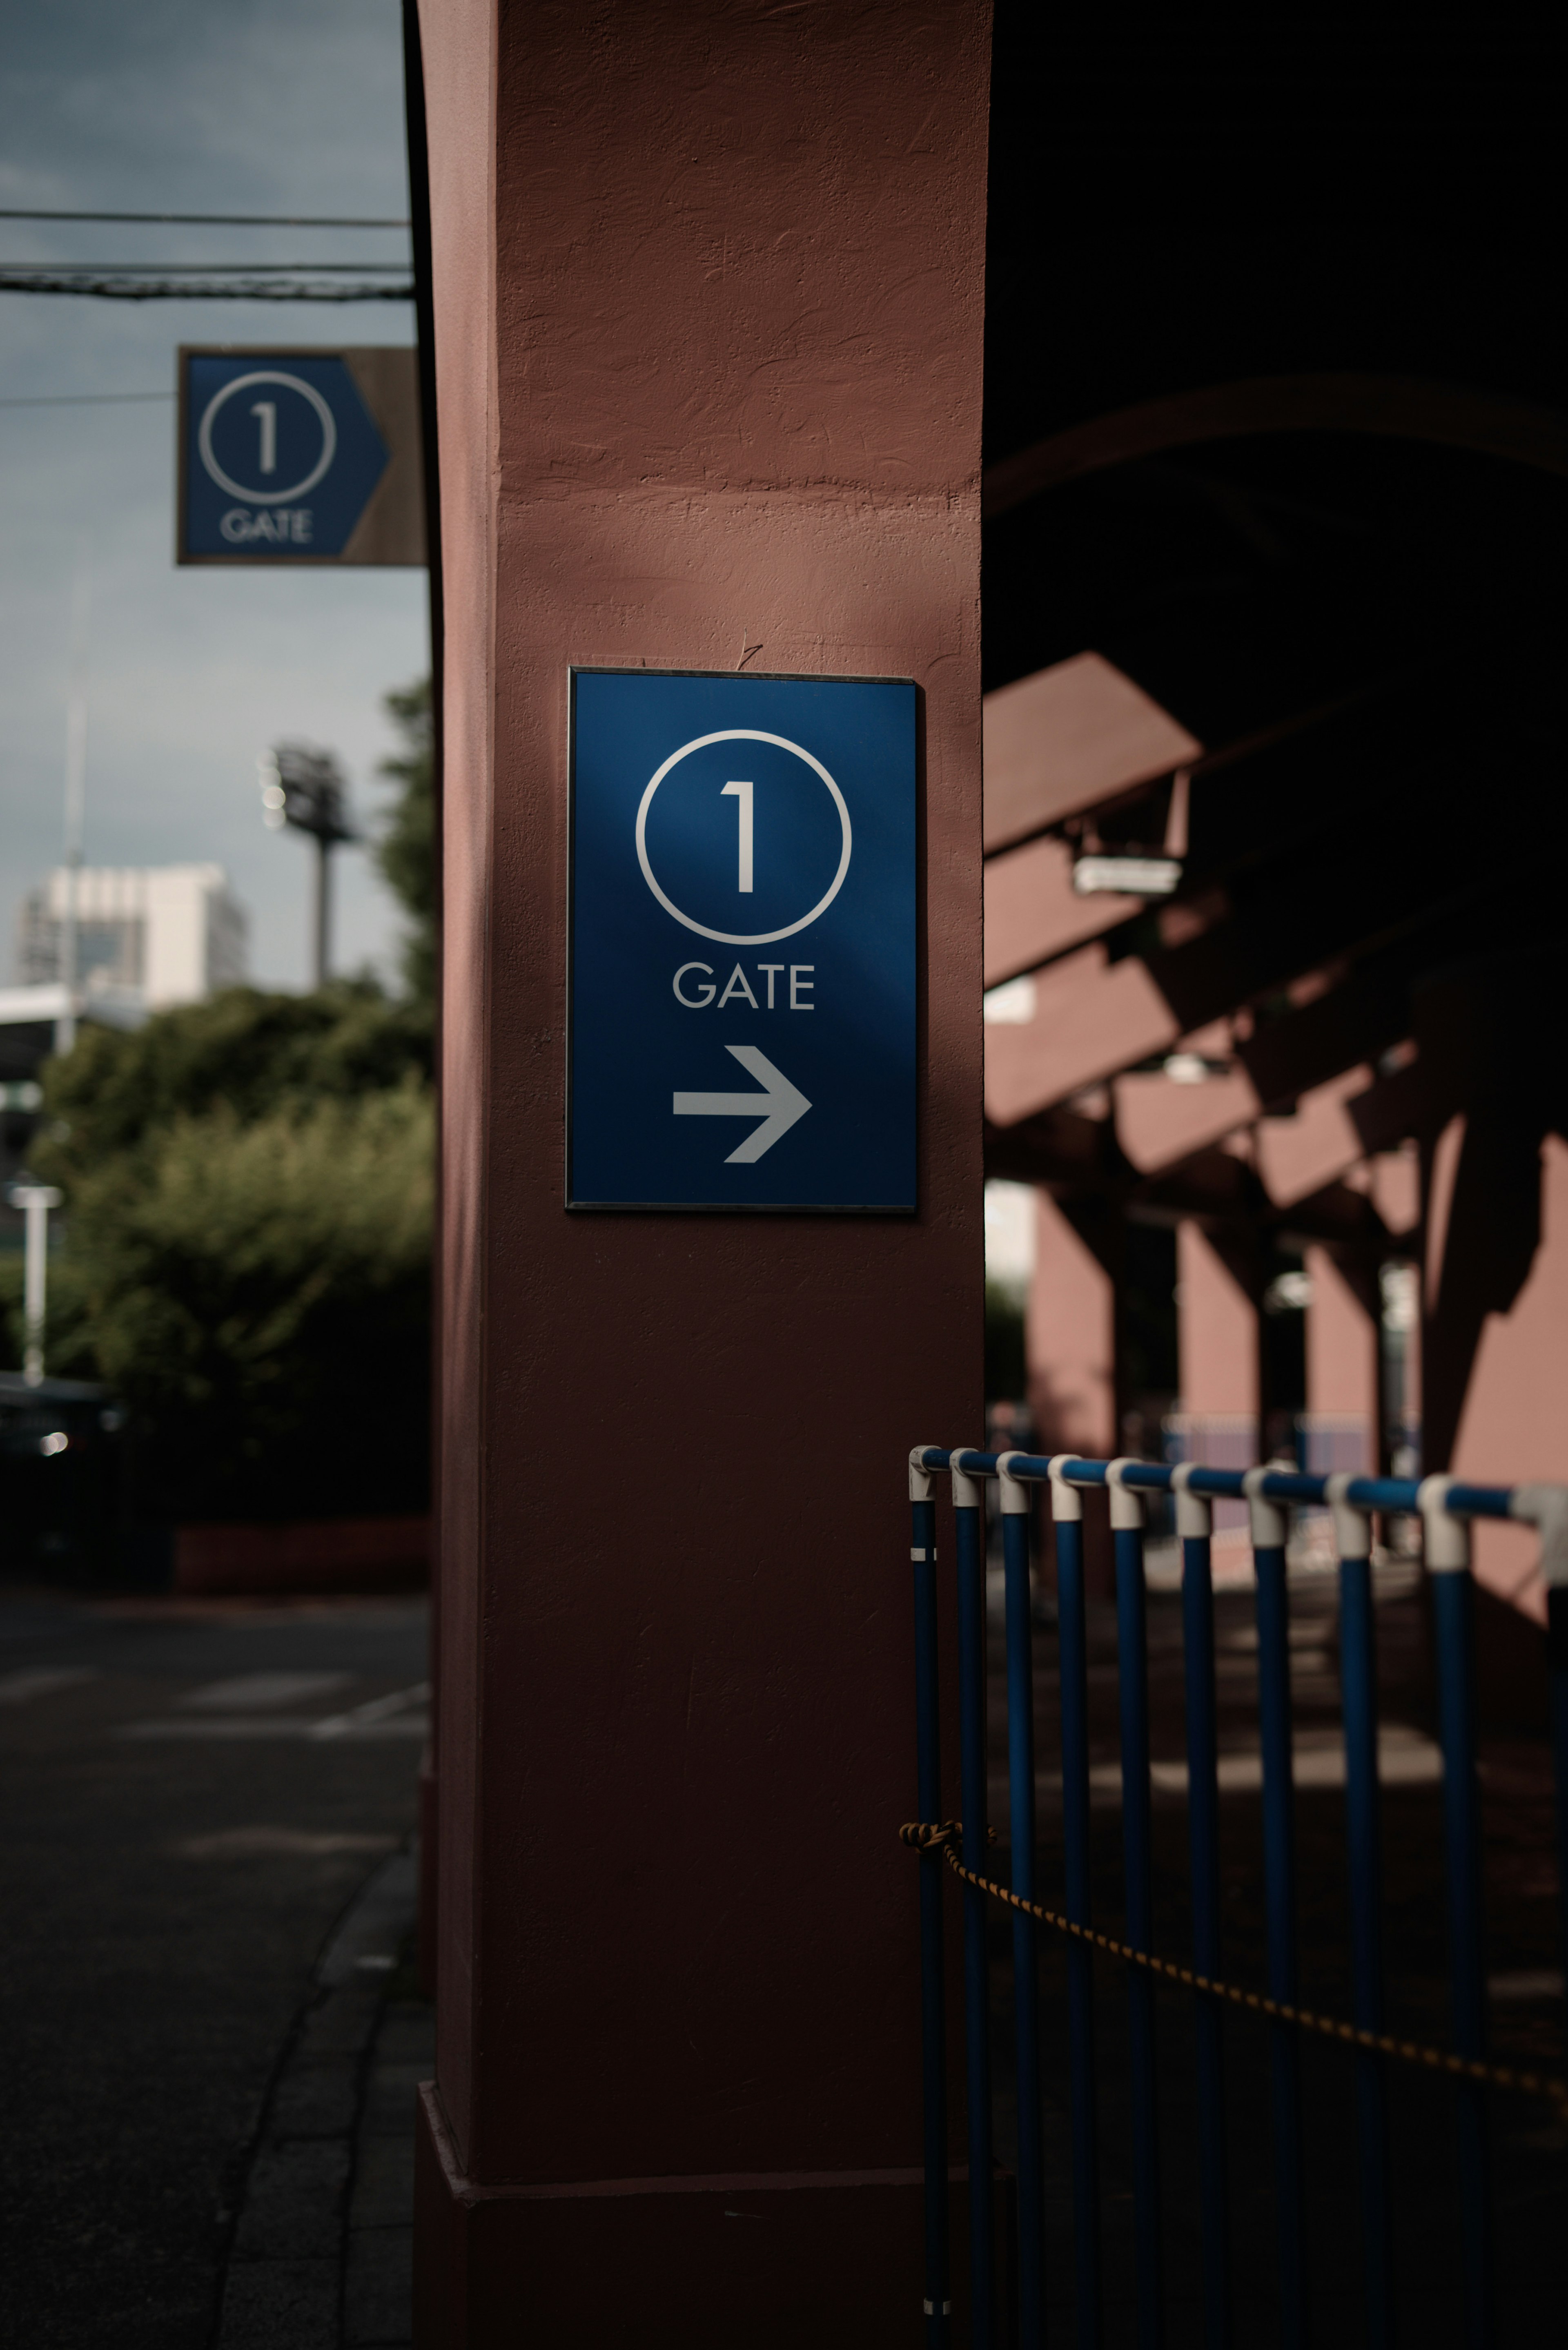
[16,865,249,1015]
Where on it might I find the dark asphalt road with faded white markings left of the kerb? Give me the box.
[0,1591,425,2350]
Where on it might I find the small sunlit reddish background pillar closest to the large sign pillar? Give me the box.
[1025,1191,1119,1459]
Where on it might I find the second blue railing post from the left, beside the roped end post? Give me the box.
[947,1450,997,2350]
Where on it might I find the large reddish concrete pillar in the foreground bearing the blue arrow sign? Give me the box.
[416,0,987,2350]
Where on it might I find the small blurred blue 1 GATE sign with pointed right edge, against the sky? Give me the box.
[179,350,388,562]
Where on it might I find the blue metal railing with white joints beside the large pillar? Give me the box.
[910,1445,1568,2350]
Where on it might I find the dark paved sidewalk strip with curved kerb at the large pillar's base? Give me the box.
[216,1852,435,2350]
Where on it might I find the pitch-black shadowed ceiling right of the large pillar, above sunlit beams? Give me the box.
[985,18,1568,1297]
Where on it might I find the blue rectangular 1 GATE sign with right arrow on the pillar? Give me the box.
[566,670,917,1213]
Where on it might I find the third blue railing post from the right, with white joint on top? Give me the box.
[1323,1476,1394,2350]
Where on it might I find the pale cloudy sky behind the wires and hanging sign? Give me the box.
[0,0,428,987]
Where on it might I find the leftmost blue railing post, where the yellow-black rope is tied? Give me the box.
[910,1445,950,2350]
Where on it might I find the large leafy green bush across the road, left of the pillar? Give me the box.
[12,985,435,1521]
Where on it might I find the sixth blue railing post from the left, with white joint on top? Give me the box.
[1171,1462,1229,2350]
